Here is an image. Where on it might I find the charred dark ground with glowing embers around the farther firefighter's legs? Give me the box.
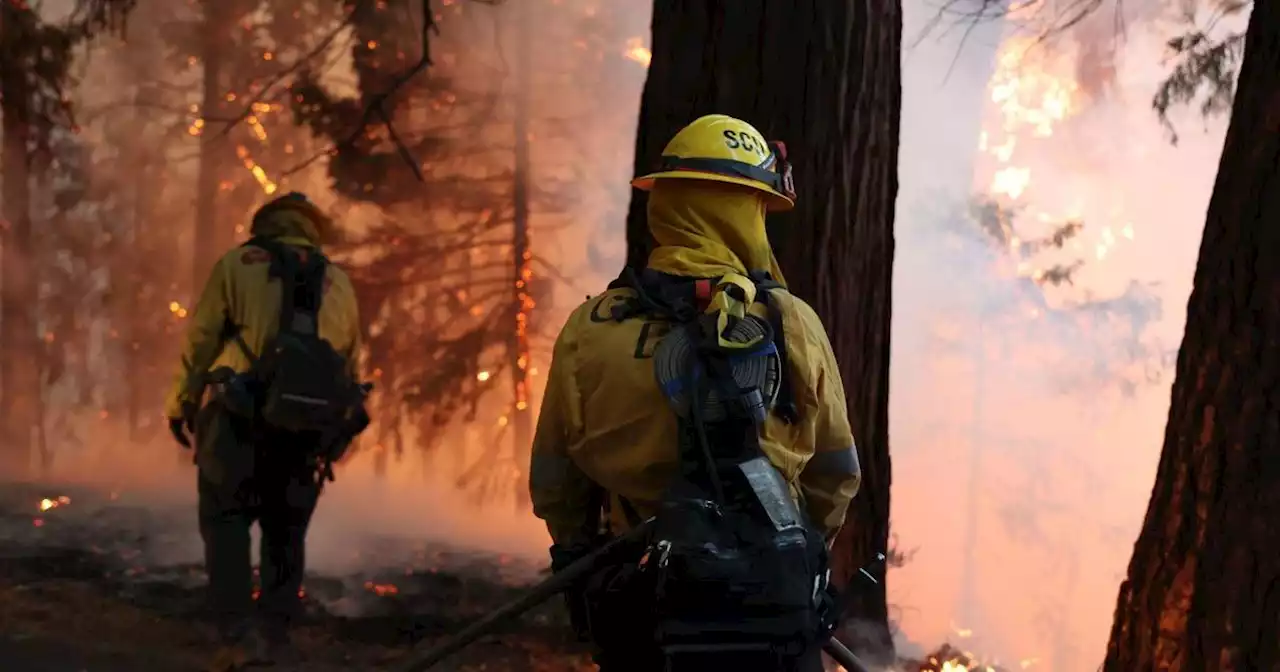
[0,485,585,671]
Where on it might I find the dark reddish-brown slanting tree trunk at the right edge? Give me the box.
[1103,0,1280,672]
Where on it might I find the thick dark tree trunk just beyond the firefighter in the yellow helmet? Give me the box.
[627,0,902,659]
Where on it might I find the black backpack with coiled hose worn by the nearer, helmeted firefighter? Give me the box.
[611,269,833,667]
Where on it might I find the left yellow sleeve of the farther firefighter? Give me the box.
[165,257,230,417]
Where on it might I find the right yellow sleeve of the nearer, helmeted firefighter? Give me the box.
[800,308,861,540]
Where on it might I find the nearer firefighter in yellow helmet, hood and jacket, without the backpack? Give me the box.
[530,115,860,671]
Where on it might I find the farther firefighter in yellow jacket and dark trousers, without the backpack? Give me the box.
[165,193,361,667]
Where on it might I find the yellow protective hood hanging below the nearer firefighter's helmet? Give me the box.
[649,179,786,287]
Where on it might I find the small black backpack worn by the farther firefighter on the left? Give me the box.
[229,238,367,438]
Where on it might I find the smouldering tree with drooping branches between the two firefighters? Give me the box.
[293,1,622,499]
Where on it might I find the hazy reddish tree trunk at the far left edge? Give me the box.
[0,3,40,477]
